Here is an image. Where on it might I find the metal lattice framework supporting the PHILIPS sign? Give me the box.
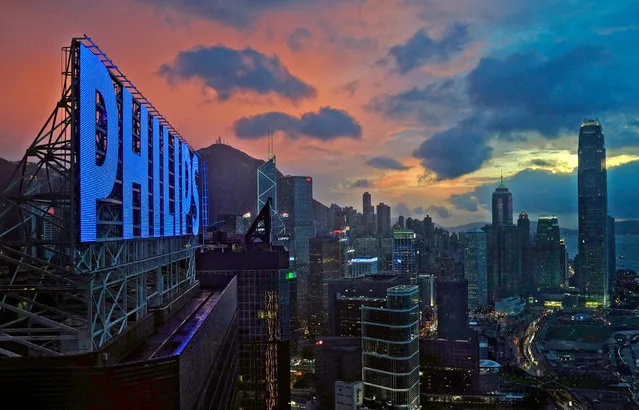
[0,36,198,357]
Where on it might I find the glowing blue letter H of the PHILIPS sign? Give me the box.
[122,88,149,239]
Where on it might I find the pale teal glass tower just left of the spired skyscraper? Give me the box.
[463,229,488,309]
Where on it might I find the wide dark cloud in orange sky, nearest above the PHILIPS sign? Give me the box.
[159,45,316,101]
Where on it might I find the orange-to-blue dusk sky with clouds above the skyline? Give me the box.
[0,0,639,228]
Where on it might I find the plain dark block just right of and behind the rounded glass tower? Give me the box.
[435,278,470,340]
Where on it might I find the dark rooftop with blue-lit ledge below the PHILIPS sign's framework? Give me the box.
[0,278,238,410]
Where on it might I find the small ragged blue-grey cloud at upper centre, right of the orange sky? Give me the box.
[388,23,470,74]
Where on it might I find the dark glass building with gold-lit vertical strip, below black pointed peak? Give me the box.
[196,246,291,410]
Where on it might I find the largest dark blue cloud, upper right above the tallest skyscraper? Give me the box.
[467,45,630,138]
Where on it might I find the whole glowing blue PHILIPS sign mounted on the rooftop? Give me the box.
[77,44,200,242]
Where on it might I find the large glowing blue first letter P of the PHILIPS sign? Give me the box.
[79,45,118,242]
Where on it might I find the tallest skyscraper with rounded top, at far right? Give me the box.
[577,119,609,307]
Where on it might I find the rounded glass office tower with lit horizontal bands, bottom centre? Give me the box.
[362,285,420,410]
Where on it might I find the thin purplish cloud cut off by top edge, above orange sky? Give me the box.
[139,0,355,30]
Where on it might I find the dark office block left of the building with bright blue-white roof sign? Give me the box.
[306,237,346,339]
